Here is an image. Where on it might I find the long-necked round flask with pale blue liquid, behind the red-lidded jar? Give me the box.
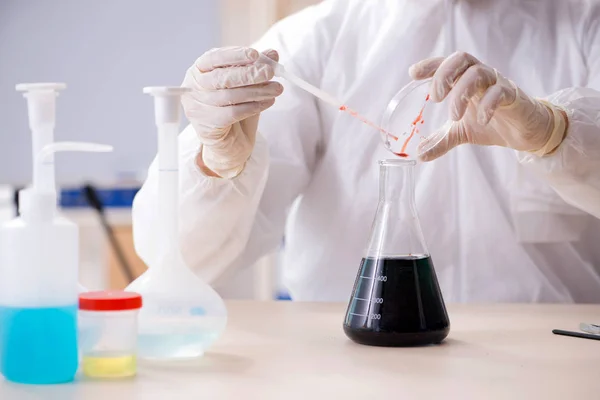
[126,87,227,360]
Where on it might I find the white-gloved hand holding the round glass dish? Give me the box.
[409,53,568,161]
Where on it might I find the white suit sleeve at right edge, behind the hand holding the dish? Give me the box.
[518,4,600,218]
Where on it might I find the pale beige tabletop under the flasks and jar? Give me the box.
[0,301,600,400]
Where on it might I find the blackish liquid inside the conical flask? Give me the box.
[344,256,450,346]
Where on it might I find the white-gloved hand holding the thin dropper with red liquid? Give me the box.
[181,47,283,178]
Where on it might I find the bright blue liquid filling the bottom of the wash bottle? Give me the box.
[0,305,78,384]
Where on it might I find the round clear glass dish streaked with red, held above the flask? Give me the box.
[381,79,452,160]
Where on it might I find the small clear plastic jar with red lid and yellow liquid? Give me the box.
[79,291,142,378]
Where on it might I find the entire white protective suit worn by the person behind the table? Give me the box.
[133,0,600,302]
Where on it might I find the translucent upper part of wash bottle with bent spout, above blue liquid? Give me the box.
[0,142,112,307]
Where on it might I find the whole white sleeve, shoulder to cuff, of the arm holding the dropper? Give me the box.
[133,1,344,286]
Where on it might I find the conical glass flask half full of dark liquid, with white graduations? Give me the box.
[344,159,450,346]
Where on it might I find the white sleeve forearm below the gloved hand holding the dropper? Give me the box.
[132,125,268,280]
